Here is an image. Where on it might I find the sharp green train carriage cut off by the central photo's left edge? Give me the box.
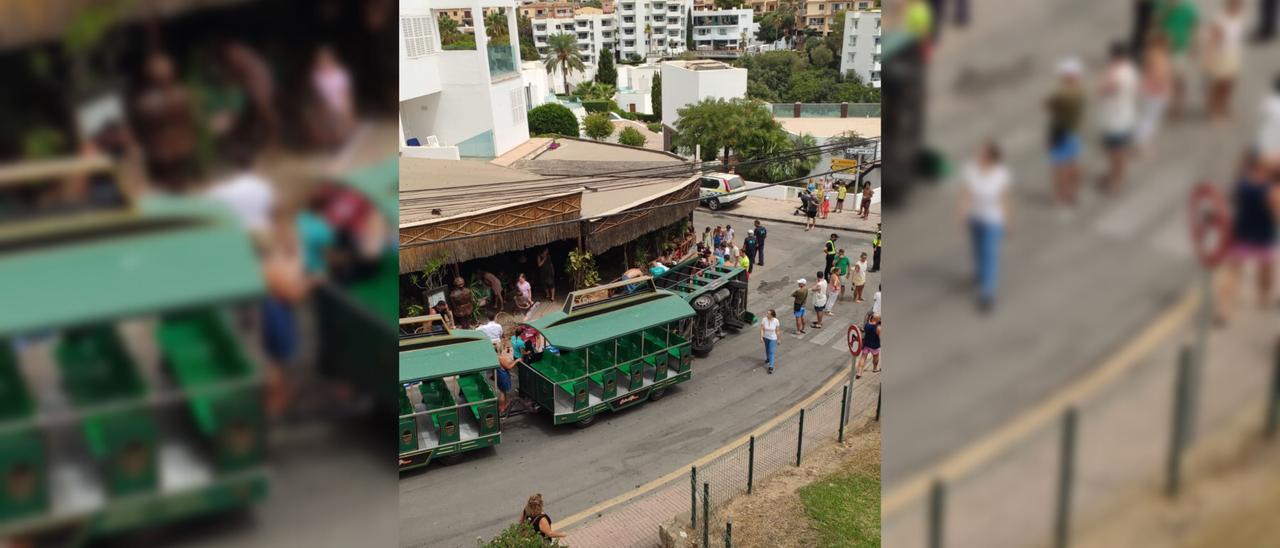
[398,315,502,470]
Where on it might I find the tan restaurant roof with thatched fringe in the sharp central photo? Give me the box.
[399,138,698,273]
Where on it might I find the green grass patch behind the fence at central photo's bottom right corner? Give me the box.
[800,467,881,547]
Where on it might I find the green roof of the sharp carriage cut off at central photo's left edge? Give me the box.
[399,329,498,383]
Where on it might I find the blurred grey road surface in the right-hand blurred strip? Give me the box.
[883,0,1280,489]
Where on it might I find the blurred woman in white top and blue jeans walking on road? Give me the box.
[960,142,1010,312]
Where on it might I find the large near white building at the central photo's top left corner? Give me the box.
[398,0,535,159]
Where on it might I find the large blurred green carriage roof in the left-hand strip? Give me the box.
[0,196,264,335]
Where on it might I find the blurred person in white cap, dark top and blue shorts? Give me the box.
[1044,58,1084,207]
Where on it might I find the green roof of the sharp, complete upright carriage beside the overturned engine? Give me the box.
[527,289,694,348]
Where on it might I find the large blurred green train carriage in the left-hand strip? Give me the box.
[0,157,268,539]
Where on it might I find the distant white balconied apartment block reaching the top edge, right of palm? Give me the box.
[613,0,694,59]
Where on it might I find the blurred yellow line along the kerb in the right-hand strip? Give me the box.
[881,288,1201,516]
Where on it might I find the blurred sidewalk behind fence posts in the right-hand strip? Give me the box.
[883,291,1275,547]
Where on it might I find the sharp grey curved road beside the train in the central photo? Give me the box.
[399,210,879,547]
